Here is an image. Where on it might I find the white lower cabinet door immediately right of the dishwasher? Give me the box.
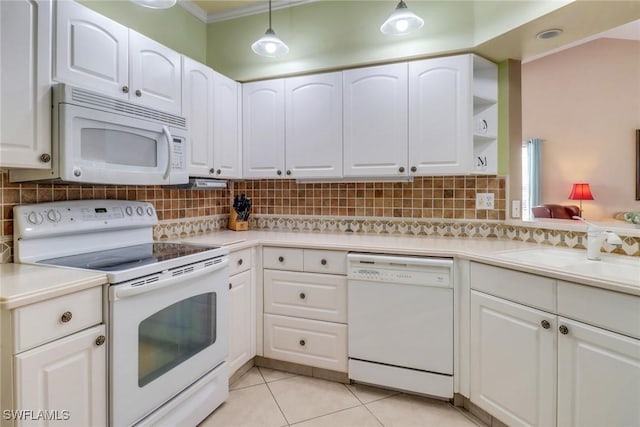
[470,291,557,427]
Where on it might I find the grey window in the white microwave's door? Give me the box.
[80,128,158,167]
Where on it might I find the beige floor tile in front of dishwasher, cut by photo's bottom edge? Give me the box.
[366,394,477,427]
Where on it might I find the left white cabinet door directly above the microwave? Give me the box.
[53,1,129,99]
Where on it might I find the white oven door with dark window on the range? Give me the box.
[109,256,229,426]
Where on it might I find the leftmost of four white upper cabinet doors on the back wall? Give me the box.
[242,79,284,178]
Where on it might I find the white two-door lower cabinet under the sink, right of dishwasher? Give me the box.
[469,262,640,427]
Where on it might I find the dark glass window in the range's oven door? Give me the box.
[138,292,216,387]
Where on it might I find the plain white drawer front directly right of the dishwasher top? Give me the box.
[471,262,556,313]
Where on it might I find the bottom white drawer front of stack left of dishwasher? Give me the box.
[264,314,347,372]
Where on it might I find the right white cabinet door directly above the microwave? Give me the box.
[129,30,181,114]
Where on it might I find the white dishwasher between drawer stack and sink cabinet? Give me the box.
[347,253,453,399]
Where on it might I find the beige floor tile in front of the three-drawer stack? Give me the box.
[268,376,360,423]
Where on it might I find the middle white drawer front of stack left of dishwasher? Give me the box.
[264,270,347,323]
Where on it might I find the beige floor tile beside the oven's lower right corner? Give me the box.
[199,384,287,427]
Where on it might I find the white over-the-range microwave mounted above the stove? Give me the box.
[54,103,189,185]
